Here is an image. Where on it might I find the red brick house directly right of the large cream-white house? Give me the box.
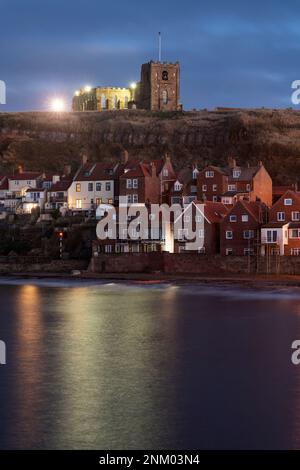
[119,161,162,205]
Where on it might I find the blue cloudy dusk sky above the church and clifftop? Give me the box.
[0,0,300,111]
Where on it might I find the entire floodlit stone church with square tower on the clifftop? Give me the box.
[72,61,181,111]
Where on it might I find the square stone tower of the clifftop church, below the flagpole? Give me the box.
[137,61,181,111]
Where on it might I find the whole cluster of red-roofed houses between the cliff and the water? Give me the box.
[0,152,300,256]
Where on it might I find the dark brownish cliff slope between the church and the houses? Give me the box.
[0,109,300,184]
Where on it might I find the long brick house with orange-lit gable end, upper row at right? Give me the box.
[197,159,272,207]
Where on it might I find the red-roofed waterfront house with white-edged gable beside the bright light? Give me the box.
[174,201,228,255]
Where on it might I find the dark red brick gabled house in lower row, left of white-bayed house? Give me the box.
[220,200,267,256]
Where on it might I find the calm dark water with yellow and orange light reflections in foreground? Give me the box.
[0,281,300,449]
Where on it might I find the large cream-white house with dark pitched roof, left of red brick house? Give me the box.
[68,163,118,211]
